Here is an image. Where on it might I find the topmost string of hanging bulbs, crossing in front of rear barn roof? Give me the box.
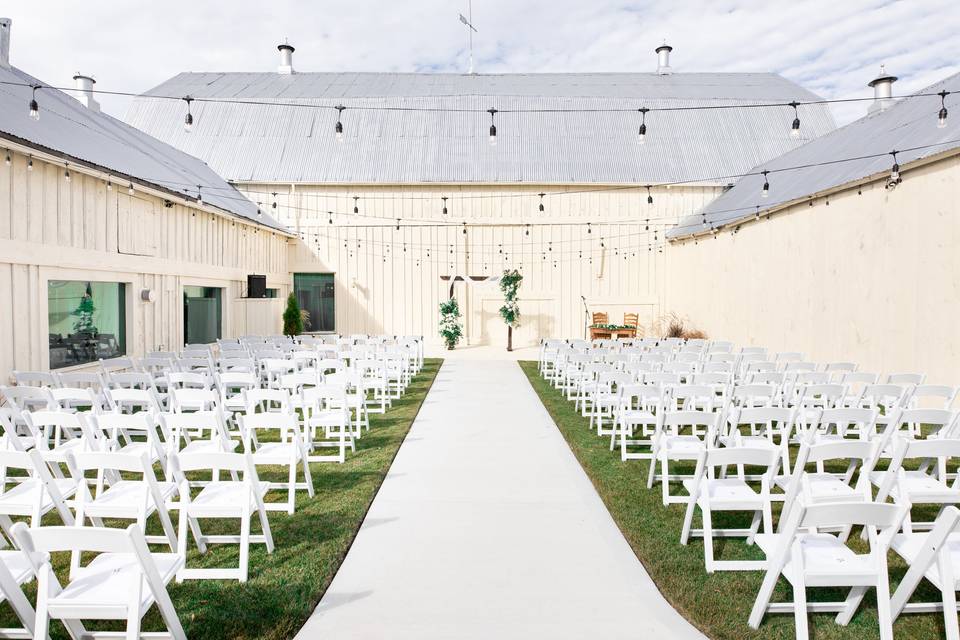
[0,80,955,145]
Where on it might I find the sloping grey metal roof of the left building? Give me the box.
[0,62,286,231]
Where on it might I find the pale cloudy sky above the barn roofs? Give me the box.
[0,0,960,123]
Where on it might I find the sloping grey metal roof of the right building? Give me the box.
[667,74,960,238]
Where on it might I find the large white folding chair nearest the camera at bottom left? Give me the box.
[13,523,187,640]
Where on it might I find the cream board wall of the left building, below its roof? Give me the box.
[0,146,293,381]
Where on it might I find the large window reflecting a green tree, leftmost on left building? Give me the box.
[47,280,127,369]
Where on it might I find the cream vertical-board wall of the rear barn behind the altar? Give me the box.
[240,184,718,346]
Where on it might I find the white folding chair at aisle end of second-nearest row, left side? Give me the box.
[170,452,273,582]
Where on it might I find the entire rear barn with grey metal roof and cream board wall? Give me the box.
[126,46,834,346]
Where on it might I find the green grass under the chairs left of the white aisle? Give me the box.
[0,359,441,640]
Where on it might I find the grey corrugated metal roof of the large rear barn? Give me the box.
[126,73,835,184]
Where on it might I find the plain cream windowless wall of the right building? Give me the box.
[667,156,960,384]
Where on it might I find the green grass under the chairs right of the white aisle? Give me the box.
[520,362,944,640]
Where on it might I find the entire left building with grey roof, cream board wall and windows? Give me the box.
[0,19,292,381]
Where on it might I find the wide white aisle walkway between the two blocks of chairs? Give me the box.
[297,360,703,640]
